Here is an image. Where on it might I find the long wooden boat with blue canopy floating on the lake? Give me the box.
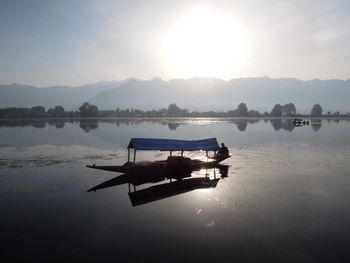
[87,138,230,175]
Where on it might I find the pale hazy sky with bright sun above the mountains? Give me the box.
[0,0,350,86]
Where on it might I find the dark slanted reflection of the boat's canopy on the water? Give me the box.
[129,177,220,206]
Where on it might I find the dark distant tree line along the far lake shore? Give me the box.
[0,102,350,118]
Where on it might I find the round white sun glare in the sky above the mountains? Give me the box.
[161,9,248,79]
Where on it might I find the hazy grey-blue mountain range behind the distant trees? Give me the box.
[0,77,350,113]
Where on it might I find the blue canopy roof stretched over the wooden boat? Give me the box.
[128,138,220,151]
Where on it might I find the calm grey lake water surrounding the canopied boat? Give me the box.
[0,119,350,262]
